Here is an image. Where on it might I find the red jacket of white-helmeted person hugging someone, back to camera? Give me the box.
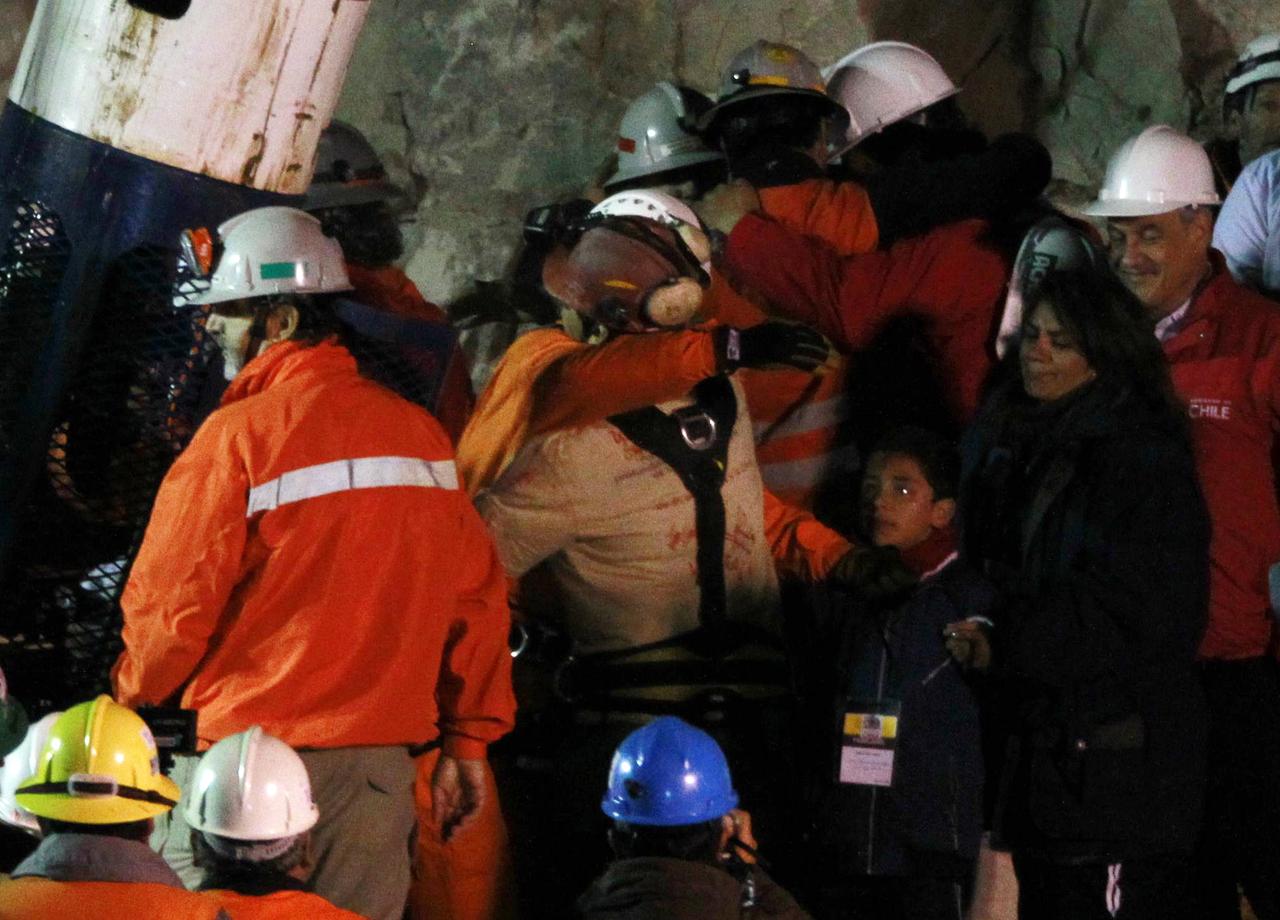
[724,214,1011,424]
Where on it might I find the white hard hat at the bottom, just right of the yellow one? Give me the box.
[183,726,320,842]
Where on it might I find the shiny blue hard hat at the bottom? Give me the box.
[600,715,737,827]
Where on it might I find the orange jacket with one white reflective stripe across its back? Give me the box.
[113,340,515,759]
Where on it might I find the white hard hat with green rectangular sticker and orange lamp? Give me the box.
[184,206,351,303]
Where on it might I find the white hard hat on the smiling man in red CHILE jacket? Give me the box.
[1084,124,1221,218]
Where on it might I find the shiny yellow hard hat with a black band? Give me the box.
[14,695,178,824]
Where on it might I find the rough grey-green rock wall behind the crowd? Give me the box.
[0,0,1280,303]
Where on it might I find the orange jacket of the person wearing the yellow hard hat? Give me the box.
[0,875,231,920]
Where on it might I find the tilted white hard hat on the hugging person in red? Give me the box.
[823,41,960,155]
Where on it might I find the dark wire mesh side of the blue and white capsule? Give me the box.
[0,215,209,711]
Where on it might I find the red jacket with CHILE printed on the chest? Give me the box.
[1165,266,1280,659]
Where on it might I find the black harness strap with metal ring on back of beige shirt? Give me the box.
[609,376,737,635]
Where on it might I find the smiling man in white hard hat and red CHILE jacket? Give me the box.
[1087,125,1280,920]
